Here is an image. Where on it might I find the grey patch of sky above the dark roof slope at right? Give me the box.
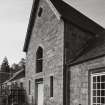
[66,0,105,28]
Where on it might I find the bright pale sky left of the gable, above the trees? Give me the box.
[0,0,32,65]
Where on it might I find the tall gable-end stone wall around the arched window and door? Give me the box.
[25,0,64,105]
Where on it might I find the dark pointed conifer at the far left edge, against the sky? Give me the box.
[1,57,10,73]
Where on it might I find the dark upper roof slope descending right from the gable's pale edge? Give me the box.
[51,0,104,34]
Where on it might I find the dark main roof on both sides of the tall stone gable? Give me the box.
[23,0,104,52]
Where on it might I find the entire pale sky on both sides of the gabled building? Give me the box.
[0,0,105,65]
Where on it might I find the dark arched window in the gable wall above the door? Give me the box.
[36,47,43,73]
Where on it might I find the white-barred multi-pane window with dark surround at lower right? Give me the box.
[89,67,105,105]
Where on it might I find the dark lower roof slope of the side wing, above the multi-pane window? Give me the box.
[68,32,105,65]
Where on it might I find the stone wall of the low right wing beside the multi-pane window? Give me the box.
[69,57,105,105]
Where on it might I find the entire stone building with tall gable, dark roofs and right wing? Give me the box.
[24,0,105,105]
